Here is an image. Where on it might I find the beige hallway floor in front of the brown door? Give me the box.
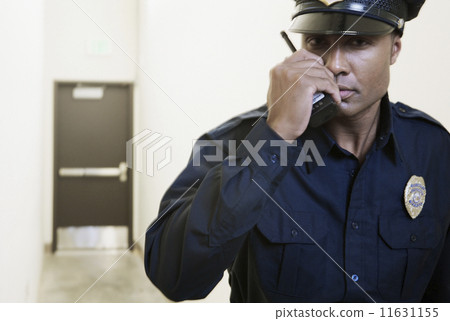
[38,250,229,303]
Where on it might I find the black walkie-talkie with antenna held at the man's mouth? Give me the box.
[281,31,338,127]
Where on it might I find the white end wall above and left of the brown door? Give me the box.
[44,0,138,244]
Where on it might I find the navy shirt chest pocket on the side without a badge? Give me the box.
[253,210,344,302]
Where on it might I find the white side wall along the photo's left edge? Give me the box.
[0,0,43,302]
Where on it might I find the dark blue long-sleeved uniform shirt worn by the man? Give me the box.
[145,95,450,302]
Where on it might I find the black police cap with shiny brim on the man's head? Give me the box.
[289,0,425,35]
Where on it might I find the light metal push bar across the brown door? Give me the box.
[58,162,128,183]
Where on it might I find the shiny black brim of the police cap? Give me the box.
[289,12,395,36]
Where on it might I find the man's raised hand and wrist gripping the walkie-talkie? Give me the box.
[267,49,341,141]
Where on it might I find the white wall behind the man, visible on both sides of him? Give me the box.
[135,0,450,301]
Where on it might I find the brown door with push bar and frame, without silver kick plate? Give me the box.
[52,83,133,251]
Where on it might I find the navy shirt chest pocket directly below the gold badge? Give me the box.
[378,212,442,302]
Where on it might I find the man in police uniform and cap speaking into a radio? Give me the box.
[145,0,450,302]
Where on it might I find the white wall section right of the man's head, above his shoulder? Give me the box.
[390,1,450,130]
